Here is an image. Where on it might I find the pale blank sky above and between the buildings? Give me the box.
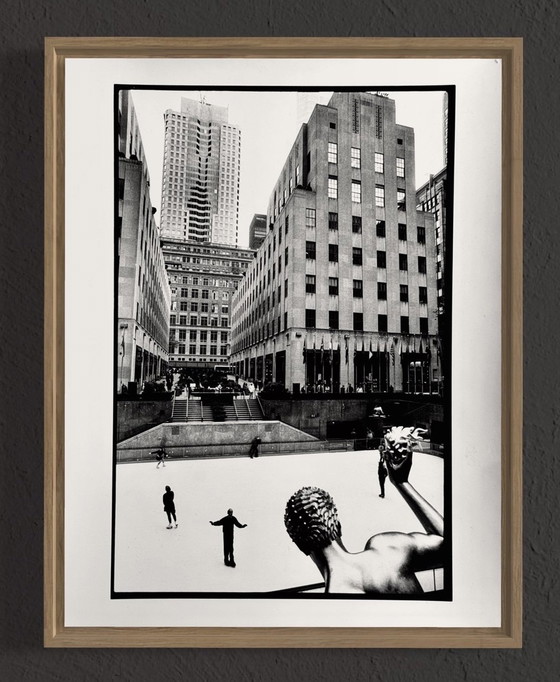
[132,90,443,247]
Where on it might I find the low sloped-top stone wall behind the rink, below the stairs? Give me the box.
[117,421,340,462]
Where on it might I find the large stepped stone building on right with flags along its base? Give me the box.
[231,92,439,392]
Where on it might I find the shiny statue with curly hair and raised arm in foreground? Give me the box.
[284,427,443,594]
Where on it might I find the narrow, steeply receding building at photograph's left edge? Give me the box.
[116,90,171,391]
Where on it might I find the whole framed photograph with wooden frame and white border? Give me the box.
[45,38,522,647]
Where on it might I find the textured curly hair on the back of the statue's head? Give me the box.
[284,486,342,554]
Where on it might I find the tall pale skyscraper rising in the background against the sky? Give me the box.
[161,98,241,246]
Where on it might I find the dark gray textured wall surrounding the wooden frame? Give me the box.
[0,0,560,682]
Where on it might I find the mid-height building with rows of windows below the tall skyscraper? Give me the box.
[162,237,255,368]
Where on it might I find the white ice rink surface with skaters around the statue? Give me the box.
[115,450,443,593]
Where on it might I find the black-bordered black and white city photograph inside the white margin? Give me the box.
[111,81,450,601]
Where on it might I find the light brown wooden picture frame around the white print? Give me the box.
[44,37,523,648]
